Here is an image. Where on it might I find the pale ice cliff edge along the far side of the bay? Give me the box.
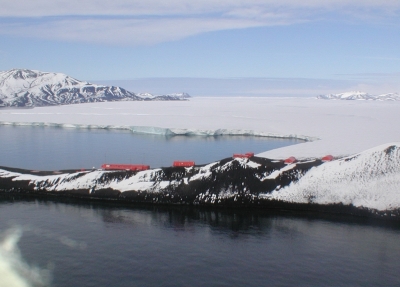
[0,121,319,141]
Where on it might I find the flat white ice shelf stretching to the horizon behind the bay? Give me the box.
[0,97,400,159]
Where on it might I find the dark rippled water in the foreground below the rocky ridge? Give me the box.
[0,200,400,287]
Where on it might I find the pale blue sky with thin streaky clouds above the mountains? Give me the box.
[0,0,400,96]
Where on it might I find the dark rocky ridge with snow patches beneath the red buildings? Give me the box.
[0,143,400,216]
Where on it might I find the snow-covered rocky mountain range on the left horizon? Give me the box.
[0,69,190,107]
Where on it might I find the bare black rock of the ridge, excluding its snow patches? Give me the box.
[0,157,400,220]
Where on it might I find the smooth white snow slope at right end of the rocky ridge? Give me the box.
[263,143,400,210]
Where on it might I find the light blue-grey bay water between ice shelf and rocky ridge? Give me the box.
[0,126,301,170]
